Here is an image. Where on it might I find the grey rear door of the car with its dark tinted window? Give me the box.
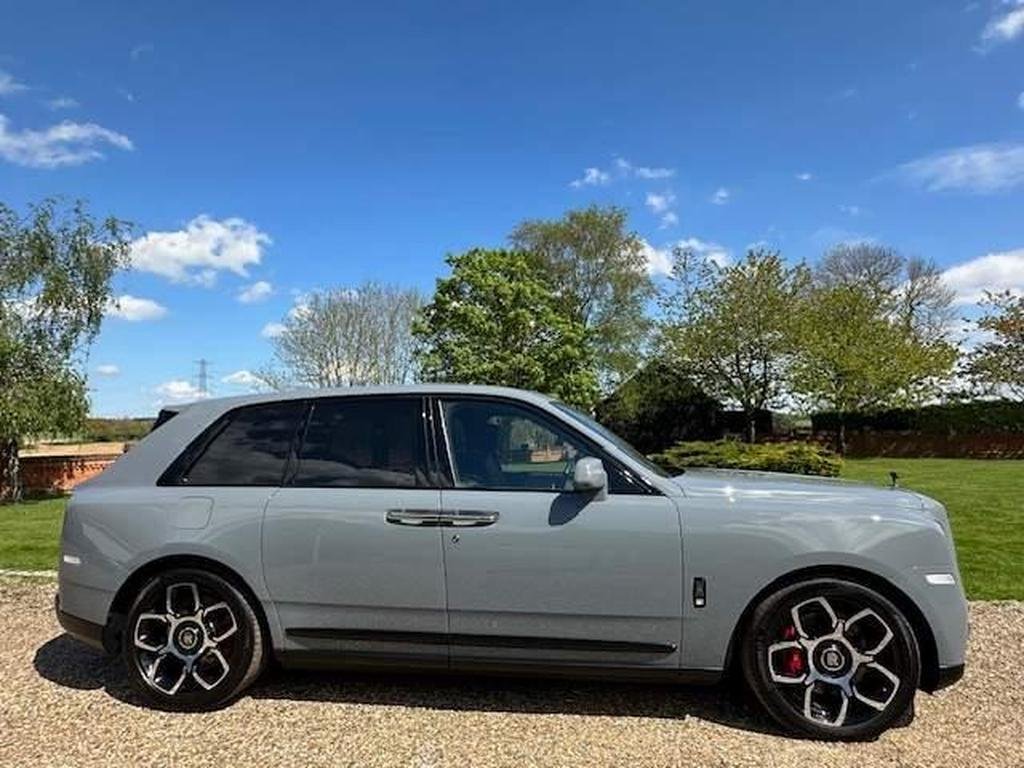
[263,396,446,666]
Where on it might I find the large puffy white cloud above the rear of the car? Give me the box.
[131,214,271,287]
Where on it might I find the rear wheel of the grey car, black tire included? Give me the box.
[121,568,267,712]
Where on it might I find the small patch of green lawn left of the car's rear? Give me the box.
[0,499,66,570]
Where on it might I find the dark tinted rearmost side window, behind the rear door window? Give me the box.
[184,400,305,485]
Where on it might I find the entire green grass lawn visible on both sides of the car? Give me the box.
[0,459,1024,600]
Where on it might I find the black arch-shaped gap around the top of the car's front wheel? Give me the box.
[725,565,939,693]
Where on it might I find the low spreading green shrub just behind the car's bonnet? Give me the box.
[650,440,843,477]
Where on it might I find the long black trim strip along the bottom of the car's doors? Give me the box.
[285,627,676,654]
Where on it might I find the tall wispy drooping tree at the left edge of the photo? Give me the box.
[0,200,129,500]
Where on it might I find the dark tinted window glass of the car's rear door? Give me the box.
[294,397,427,487]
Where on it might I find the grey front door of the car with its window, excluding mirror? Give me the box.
[439,397,682,668]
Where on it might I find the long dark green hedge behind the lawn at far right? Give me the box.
[811,400,1024,434]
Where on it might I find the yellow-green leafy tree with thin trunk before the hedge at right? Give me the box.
[792,279,956,454]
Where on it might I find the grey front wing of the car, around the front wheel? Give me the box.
[677,481,967,669]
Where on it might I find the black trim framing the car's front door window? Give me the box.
[429,392,664,496]
